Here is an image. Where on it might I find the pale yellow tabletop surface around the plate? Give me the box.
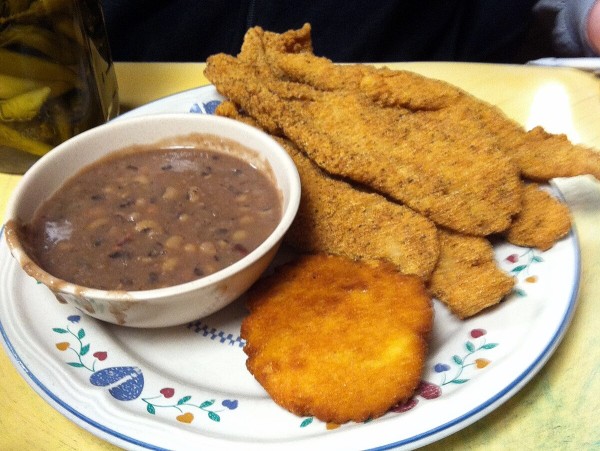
[0,63,600,451]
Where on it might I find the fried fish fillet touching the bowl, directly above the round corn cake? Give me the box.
[216,102,439,279]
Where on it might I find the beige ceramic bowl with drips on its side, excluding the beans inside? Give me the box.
[5,114,300,327]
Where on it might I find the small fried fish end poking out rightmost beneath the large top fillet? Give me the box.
[506,183,571,251]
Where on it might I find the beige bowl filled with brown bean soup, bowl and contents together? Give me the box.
[5,114,300,327]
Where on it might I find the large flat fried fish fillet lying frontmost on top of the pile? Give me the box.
[205,34,521,235]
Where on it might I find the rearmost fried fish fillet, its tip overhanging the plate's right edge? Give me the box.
[258,25,600,181]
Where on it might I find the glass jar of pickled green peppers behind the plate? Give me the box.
[0,0,119,173]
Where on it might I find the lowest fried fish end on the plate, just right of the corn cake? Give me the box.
[429,229,515,319]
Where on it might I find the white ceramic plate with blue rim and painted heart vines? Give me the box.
[0,87,580,450]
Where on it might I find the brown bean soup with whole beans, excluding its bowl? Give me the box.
[24,148,282,290]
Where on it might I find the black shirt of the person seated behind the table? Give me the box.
[102,0,535,62]
